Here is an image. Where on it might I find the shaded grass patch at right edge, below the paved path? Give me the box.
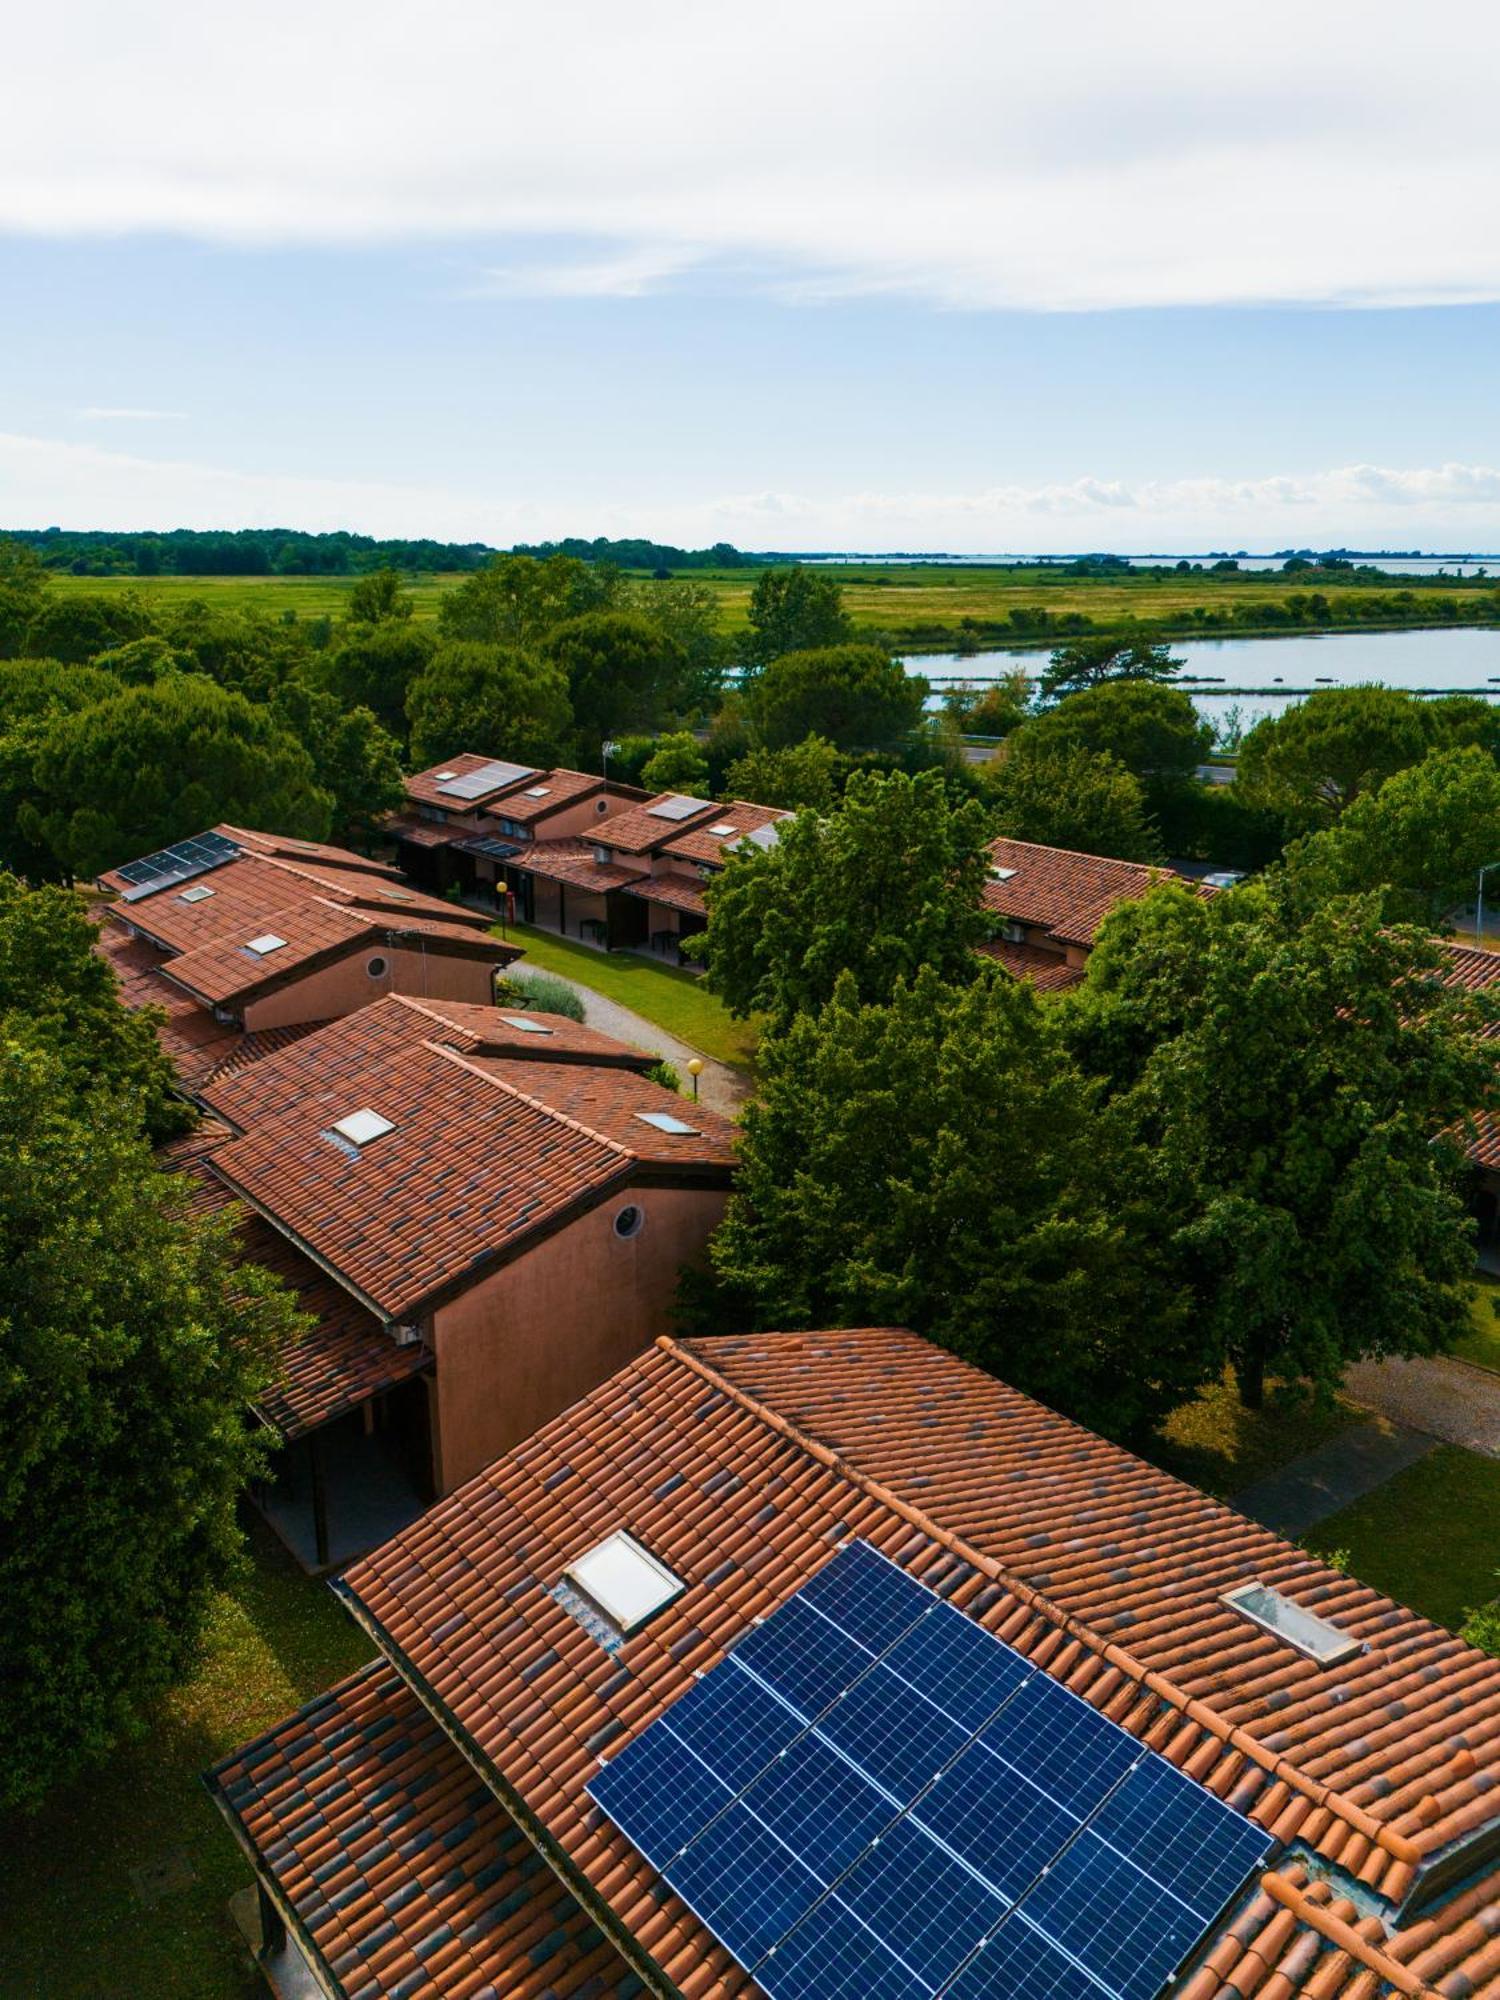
[1306,1444,1500,1630]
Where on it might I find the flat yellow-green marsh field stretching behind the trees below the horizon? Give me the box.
[52,562,1500,650]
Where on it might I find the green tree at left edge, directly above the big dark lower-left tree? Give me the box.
[0,872,194,1142]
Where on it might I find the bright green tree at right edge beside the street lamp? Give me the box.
[1286,746,1500,926]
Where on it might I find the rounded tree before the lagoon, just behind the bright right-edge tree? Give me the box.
[1234,688,1432,832]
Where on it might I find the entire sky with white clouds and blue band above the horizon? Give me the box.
[0,0,1500,554]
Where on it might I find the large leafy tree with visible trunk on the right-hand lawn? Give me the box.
[1062,882,1500,1408]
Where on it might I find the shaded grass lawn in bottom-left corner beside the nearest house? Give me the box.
[0,1522,370,2000]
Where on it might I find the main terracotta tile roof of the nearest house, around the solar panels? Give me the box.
[334,1328,1500,2000]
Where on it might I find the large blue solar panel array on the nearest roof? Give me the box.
[588,1542,1274,2000]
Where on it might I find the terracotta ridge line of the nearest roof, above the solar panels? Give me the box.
[656,1334,1422,1868]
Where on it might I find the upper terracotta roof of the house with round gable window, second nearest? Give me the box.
[204,998,734,1320]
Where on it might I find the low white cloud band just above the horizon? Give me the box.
[0,432,1500,554]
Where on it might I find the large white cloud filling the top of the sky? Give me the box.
[0,0,1500,308]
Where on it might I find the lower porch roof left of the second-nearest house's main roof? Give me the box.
[160,1118,432,1440]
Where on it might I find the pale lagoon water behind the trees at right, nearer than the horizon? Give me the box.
[906,626,1500,726]
